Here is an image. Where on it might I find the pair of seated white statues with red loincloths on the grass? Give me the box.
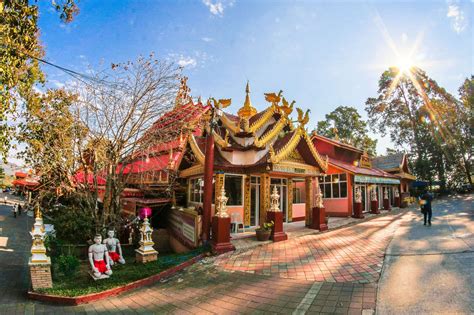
[88,230,125,280]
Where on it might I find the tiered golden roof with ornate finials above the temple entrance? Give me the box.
[208,83,328,171]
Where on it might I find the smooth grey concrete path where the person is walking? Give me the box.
[377,195,474,314]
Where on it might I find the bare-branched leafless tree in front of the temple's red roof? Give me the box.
[74,55,180,230]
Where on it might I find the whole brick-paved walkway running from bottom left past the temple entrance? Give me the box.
[0,207,408,314]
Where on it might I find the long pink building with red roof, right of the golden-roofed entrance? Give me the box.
[311,133,400,217]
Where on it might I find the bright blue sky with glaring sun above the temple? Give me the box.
[39,0,474,157]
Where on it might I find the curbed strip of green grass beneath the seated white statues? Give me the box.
[37,247,207,297]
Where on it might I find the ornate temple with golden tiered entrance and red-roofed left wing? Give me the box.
[124,79,328,246]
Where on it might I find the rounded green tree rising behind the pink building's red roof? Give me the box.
[316,106,377,156]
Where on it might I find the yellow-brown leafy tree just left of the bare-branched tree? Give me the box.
[18,89,87,190]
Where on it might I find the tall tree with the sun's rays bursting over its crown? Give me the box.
[366,67,462,190]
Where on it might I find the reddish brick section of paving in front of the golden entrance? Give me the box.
[216,216,399,283]
